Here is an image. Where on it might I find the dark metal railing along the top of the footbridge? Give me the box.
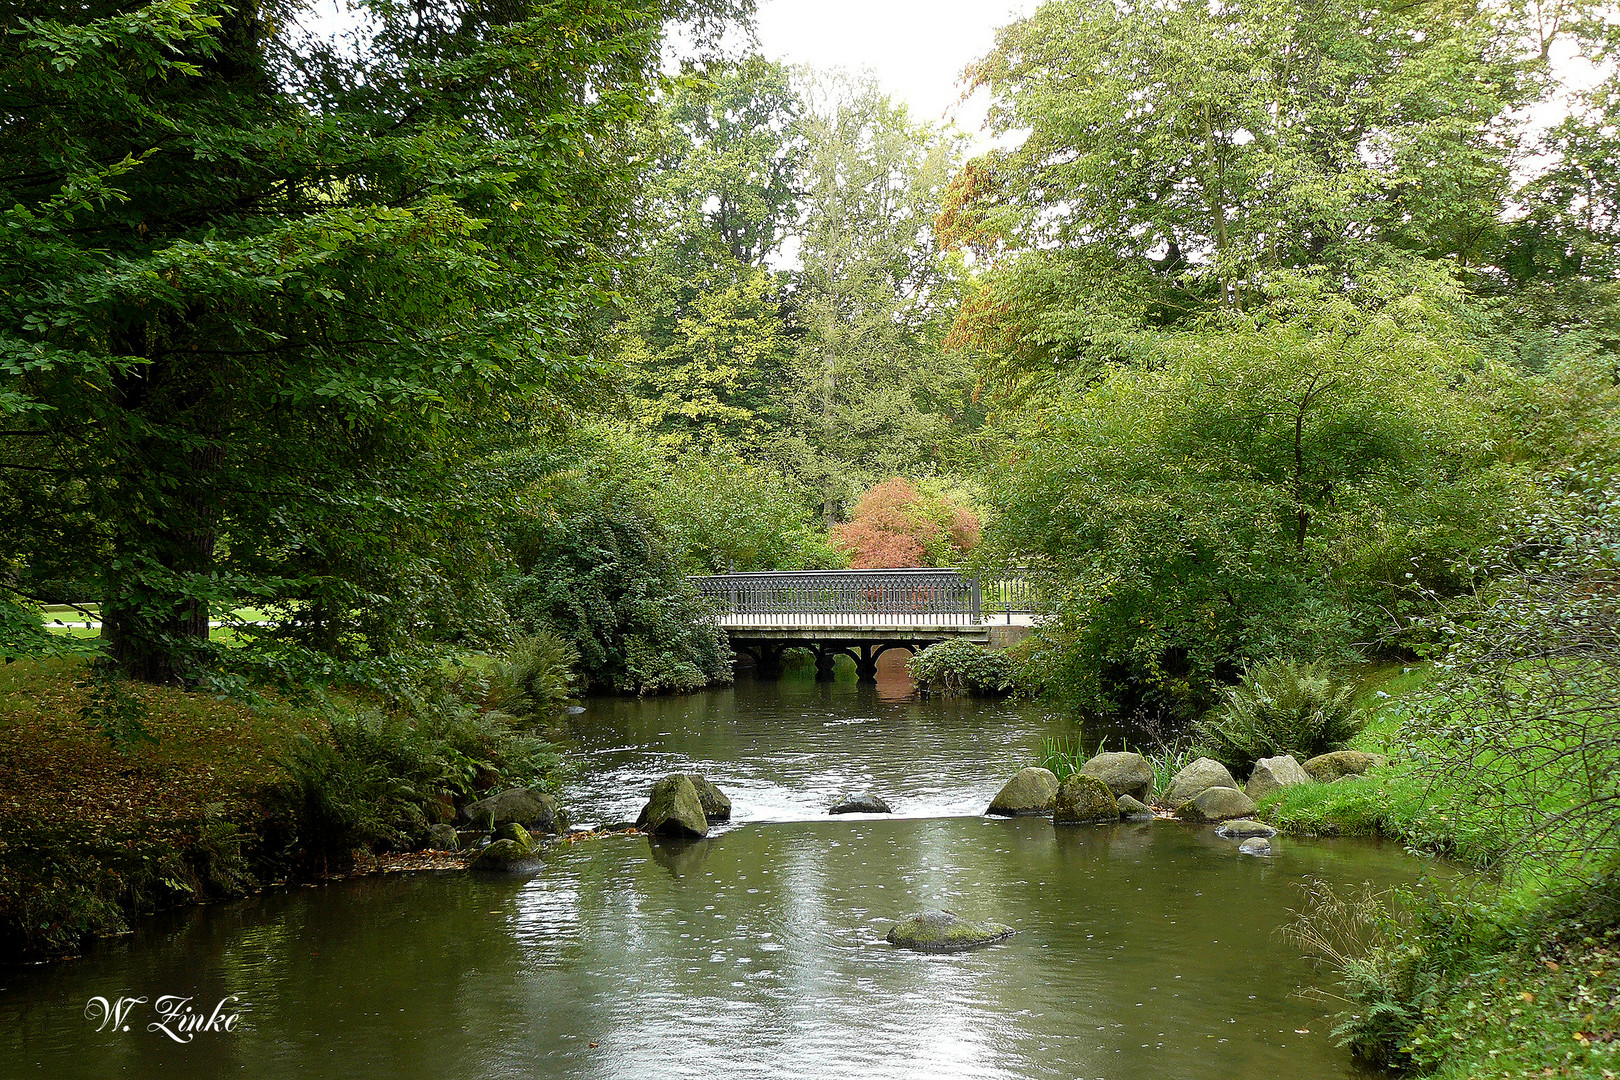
[692,568,1030,627]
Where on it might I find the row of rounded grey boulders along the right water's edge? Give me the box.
[985,750,1387,852]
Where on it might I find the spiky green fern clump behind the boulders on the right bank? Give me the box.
[1197,659,1362,772]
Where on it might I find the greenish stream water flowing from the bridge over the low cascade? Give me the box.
[0,654,1445,1080]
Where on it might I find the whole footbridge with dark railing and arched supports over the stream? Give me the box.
[692,570,1034,682]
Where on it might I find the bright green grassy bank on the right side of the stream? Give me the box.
[1262,665,1620,1080]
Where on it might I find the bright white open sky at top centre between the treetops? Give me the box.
[758,0,1037,136]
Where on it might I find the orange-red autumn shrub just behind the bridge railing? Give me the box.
[833,476,982,570]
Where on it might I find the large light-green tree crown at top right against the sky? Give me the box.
[940,0,1531,402]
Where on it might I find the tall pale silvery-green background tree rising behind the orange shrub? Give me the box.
[774,76,977,520]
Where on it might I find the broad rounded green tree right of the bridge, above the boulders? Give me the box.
[991,280,1524,729]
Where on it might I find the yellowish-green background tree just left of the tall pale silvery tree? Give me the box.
[620,57,802,449]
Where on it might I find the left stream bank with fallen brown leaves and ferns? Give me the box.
[0,659,559,959]
